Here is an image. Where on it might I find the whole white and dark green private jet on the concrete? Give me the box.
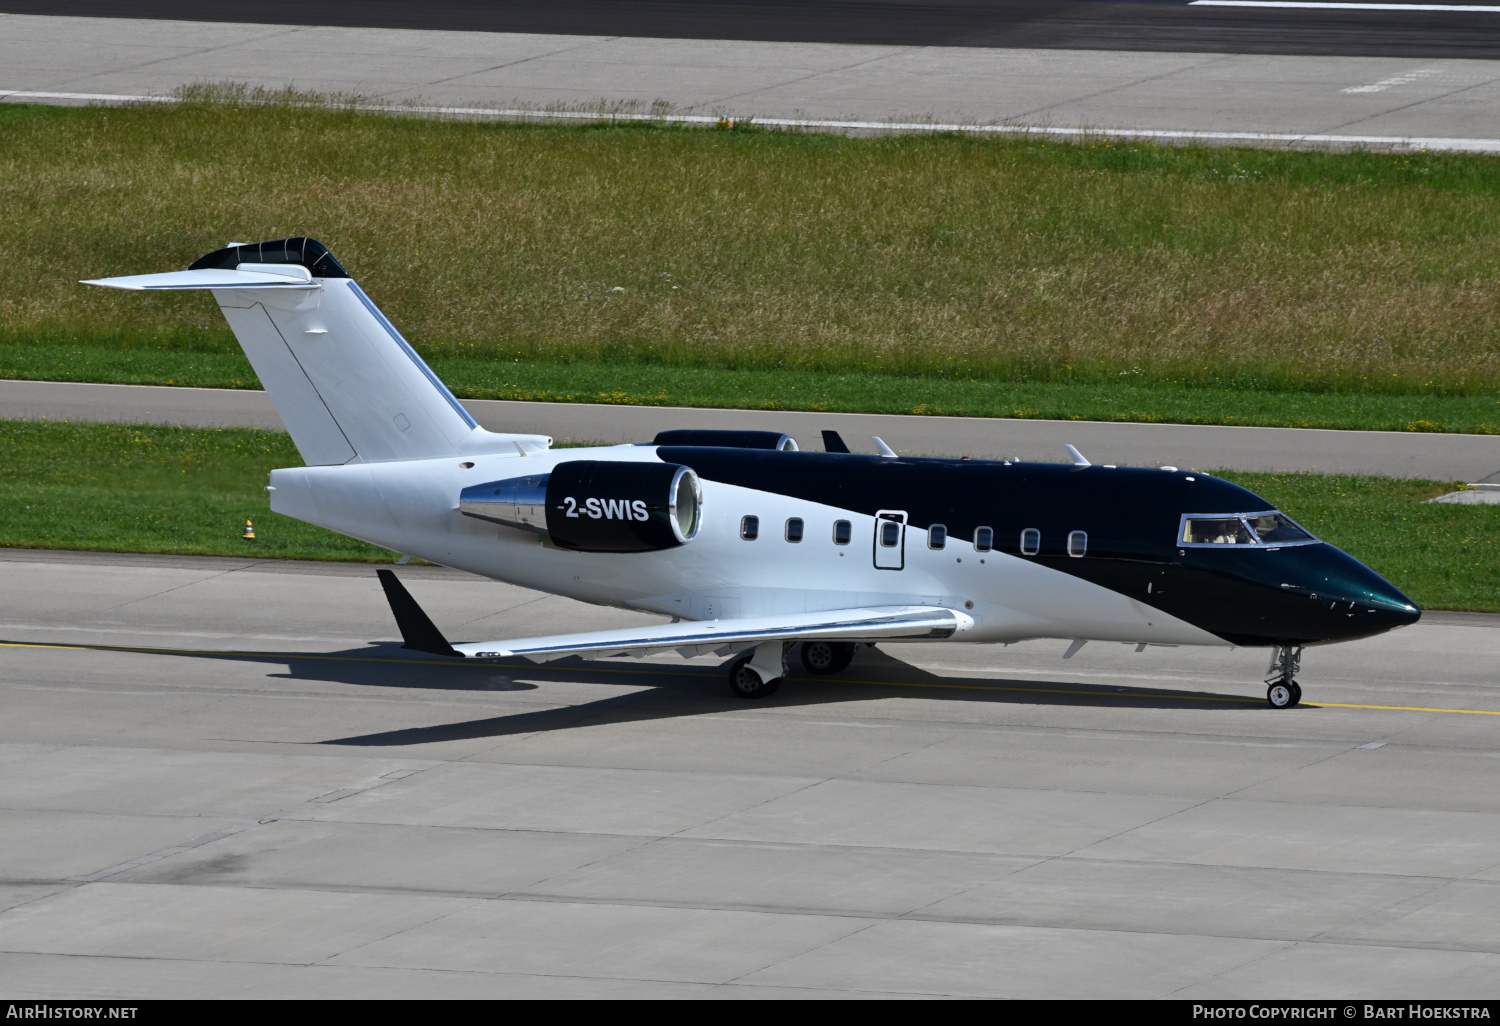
[87,239,1421,708]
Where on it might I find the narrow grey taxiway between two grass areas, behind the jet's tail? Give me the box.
[0,380,1500,483]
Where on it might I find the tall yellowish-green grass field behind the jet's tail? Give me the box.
[0,95,1500,431]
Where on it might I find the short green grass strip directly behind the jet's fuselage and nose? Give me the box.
[0,422,1500,612]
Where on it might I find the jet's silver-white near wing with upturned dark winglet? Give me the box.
[378,570,974,663]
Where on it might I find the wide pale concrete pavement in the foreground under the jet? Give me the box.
[0,551,1500,999]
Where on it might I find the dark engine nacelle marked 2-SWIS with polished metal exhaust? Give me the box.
[459,459,704,552]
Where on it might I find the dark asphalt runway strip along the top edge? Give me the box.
[0,0,1500,59]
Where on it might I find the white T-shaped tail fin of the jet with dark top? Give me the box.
[87,237,552,467]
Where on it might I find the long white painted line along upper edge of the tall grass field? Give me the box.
[0,89,1500,153]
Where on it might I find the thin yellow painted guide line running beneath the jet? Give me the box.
[0,642,1500,716]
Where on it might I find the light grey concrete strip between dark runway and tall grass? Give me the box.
[0,14,1500,153]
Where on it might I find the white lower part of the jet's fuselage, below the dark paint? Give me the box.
[272,446,1227,645]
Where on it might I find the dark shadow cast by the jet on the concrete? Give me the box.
[5,642,1284,747]
